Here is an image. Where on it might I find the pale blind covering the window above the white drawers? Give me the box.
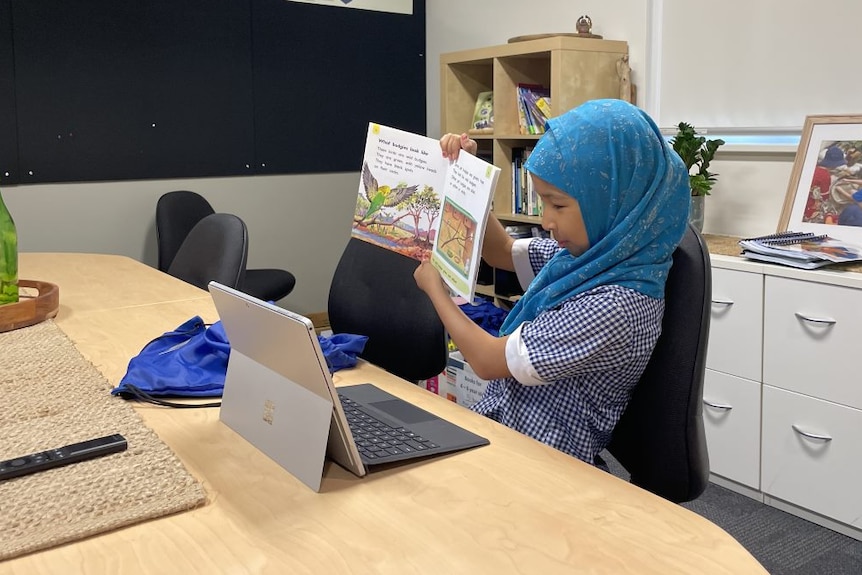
[649,0,862,134]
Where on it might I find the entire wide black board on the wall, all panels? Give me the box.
[0,0,425,183]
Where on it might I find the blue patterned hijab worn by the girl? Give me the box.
[500,100,691,334]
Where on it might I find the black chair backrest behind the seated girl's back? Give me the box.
[608,226,712,503]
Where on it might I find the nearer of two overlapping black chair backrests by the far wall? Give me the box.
[168,214,248,289]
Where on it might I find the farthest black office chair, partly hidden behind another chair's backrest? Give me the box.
[156,190,296,301]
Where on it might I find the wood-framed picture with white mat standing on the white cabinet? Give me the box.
[778,115,862,245]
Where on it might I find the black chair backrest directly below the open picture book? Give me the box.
[328,238,448,382]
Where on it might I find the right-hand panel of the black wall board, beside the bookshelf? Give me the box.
[252,0,426,173]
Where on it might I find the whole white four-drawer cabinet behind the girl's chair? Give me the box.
[703,255,862,540]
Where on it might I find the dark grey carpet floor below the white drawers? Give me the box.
[602,453,862,575]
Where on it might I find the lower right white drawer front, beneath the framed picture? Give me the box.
[762,385,862,528]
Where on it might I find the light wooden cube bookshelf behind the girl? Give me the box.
[440,36,628,301]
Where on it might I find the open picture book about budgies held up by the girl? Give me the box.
[351,123,500,301]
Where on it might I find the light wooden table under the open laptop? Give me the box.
[0,254,766,575]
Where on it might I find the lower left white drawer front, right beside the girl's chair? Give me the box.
[703,369,760,489]
